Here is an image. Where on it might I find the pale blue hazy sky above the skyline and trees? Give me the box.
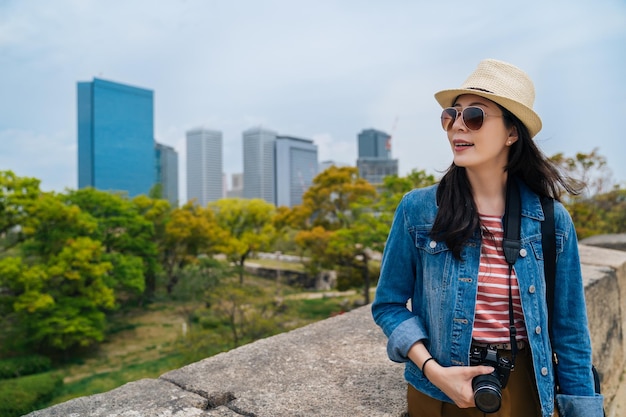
[0,0,626,201]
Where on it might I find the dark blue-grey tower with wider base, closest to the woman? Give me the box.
[356,129,398,184]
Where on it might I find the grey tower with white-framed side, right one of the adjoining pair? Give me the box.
[275,136,318,207]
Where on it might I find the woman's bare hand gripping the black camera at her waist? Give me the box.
[424,361,494,408]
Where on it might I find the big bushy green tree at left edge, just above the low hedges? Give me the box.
[0,237,115,353]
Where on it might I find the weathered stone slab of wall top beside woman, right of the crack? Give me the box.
[161,306,406,416]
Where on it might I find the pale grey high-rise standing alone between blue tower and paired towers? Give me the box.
[187,128,224,206]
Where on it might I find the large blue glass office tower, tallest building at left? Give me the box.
[77,78,157,197]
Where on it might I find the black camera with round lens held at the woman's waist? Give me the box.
[470,346,513,413]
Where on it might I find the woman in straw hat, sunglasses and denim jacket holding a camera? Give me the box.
[372,59,603,417]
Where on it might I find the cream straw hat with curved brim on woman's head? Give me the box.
[435,59,541,138]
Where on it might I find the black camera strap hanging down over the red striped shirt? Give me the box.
[502,175,522,368]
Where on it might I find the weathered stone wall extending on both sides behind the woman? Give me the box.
[28,239,626,417]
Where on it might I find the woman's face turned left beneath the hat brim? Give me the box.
[447,94,518,172]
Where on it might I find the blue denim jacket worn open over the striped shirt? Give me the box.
[372,181,603,417]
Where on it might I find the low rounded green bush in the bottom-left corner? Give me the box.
[0,372,63,417]
